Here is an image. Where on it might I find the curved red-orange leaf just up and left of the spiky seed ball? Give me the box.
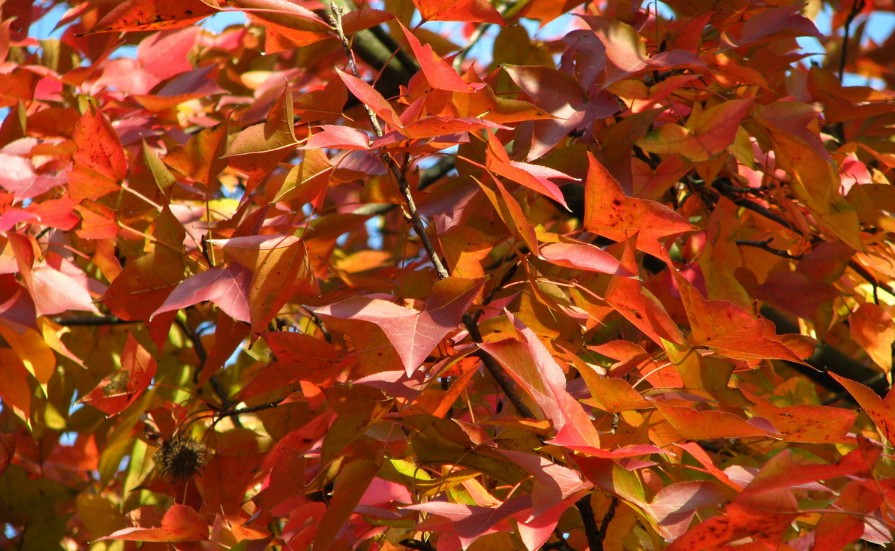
[81,334,157,416]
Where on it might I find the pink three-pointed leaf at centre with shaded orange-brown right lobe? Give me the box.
[315,277,484,376]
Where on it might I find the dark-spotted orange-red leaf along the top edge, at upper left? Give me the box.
[87,0,216,34]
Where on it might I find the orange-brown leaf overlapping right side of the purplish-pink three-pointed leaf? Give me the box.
[209,235,318,333]
